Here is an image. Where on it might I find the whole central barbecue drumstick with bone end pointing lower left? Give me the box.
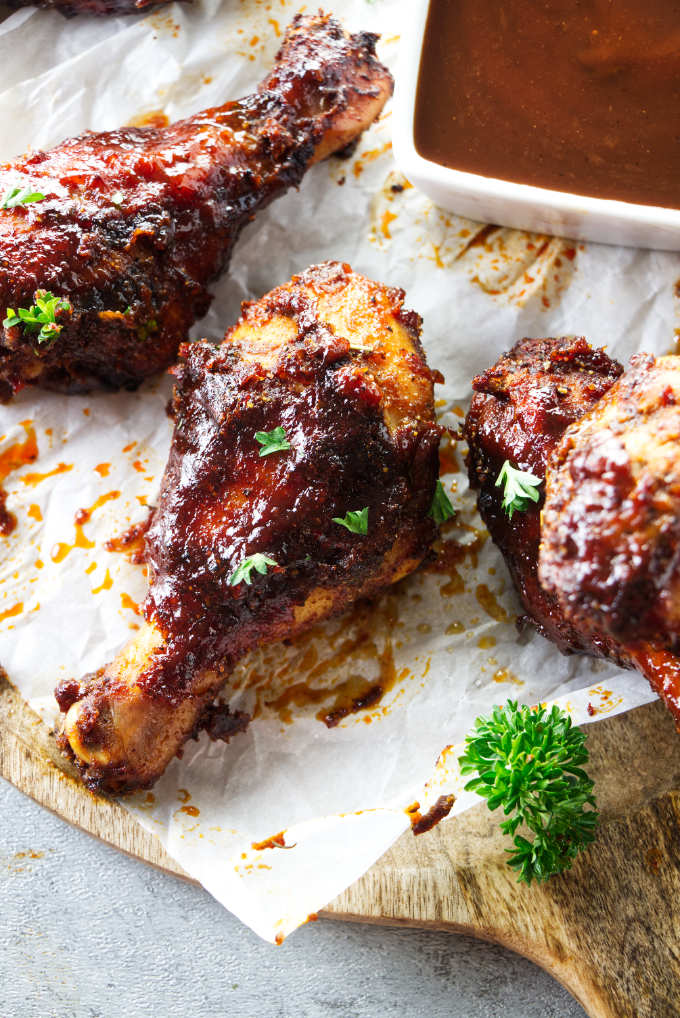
[56,263,440,791]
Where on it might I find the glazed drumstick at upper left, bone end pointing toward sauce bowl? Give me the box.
[0,13,392,400]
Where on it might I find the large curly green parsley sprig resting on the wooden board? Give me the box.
[459,700,599,884]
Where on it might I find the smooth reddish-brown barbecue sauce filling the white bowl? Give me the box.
[415,0,680,209]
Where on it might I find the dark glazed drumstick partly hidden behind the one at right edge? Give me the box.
[464,337,623,657]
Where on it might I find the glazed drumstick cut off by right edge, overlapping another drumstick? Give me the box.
[539,355,680,725]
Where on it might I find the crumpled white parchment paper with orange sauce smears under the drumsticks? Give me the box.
[0,0,680,941]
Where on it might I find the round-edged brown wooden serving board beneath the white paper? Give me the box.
[0,673,680,1018]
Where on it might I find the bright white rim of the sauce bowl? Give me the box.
[393,0,680,233]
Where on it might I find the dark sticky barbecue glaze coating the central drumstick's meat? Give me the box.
[140,267,439,698]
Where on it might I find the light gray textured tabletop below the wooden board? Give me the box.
[0,780,584,1018]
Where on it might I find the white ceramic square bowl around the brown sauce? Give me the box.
[393,0,680,250]
